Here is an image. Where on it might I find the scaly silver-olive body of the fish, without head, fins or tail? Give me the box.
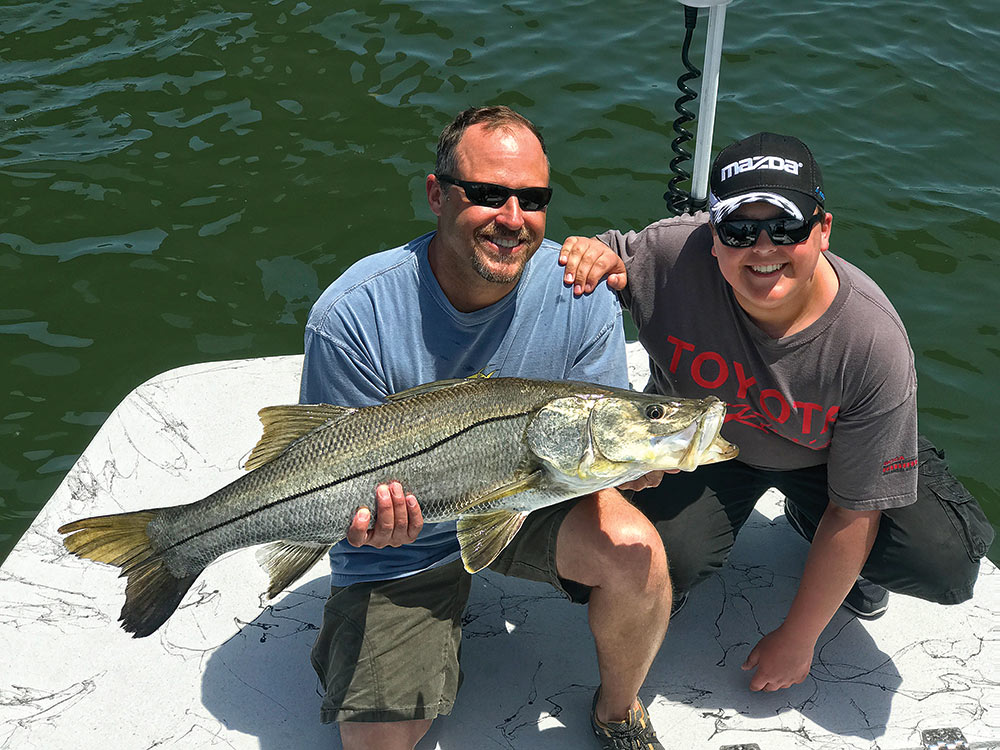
[150,379,570,574]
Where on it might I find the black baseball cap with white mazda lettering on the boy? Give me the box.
[709,133,826,224]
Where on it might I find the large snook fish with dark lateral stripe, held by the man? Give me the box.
[59,378,737,638]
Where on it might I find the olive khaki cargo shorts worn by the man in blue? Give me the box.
[312,499,590,723]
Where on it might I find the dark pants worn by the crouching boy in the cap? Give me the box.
[632,437,993,604]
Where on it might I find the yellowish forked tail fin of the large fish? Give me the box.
[59,510,201,638]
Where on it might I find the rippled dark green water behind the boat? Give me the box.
[0,0,1000,561]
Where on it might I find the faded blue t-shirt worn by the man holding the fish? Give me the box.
[299,232,628,586]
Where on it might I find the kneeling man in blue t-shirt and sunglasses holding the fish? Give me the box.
[300,107,671,750]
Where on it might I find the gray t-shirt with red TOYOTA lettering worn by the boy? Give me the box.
[598,213,917,510]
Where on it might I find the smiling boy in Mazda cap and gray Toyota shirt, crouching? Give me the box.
[560,133,993,690]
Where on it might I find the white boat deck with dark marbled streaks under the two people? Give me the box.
[0,349,1000,750]
